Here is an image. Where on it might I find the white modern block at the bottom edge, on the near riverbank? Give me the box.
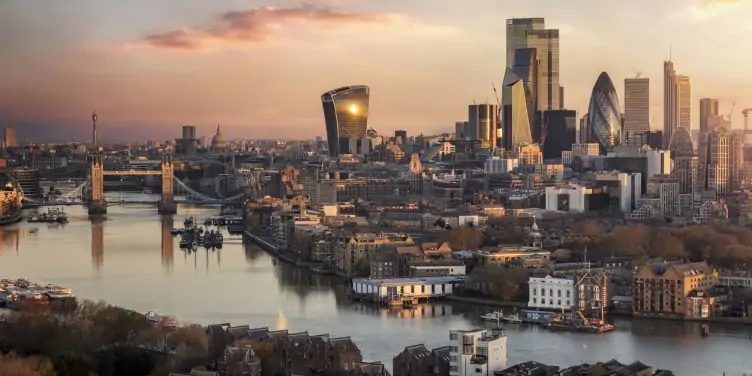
[449,329,507,376]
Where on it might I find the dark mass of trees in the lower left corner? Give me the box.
[0,301,208,376]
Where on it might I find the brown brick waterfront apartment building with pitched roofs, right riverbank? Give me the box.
[632,261,718,316]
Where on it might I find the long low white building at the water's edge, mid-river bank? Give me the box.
[350,276,465,307]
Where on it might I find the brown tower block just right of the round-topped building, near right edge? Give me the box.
[700,128,732,196]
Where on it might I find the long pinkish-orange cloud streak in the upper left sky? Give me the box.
[120,5,399,51]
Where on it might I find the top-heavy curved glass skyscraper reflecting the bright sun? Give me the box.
[321,85,370,157]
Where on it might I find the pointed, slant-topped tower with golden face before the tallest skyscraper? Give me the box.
[501,68,533,151]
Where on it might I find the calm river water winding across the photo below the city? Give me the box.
[0,200,752,376]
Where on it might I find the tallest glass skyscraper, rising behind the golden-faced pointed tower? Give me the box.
[506,18,562,111]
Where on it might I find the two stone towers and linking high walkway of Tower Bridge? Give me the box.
[89,154,178,215]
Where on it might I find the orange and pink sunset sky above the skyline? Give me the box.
[0,0,752,140]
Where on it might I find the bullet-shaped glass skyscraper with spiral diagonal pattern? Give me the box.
[588,72,621,154]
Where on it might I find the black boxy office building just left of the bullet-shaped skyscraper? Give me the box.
[541,110,577,160]
